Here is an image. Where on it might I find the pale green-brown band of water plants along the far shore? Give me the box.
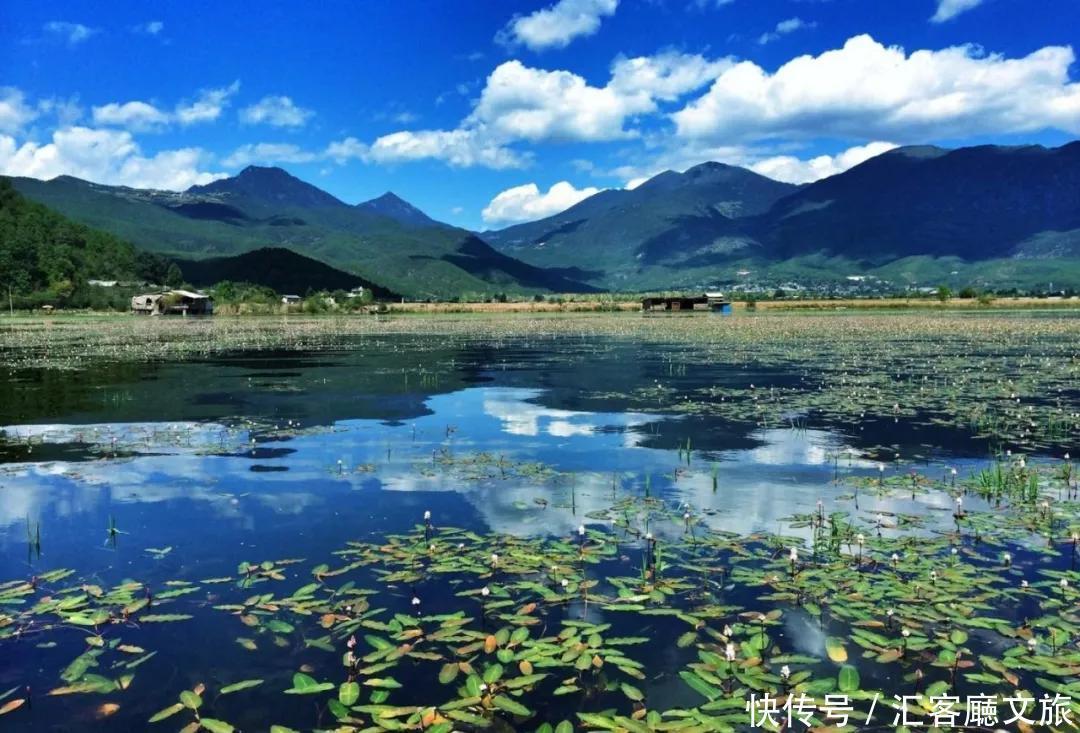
[0,300,1080,369]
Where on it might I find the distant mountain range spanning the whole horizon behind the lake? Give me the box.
[12,141,1080,298]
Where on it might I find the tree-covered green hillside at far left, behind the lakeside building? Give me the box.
[0,178,168,306]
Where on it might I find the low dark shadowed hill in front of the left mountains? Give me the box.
[176,247,400,298]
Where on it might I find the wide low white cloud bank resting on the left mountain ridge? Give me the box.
[0,126,225,191]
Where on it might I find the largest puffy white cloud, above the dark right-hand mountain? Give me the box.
[672,36,1080,142]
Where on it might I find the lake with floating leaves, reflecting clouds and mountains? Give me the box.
[0,314,1080,733]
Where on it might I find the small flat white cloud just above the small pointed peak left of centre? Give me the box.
[365,130,527,169]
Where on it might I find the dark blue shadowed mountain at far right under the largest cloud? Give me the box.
[752,142,1080,266]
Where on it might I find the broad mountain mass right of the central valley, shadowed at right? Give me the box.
[483,142,1080,289]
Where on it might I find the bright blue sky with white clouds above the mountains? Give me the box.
[0,0,1080,229]
